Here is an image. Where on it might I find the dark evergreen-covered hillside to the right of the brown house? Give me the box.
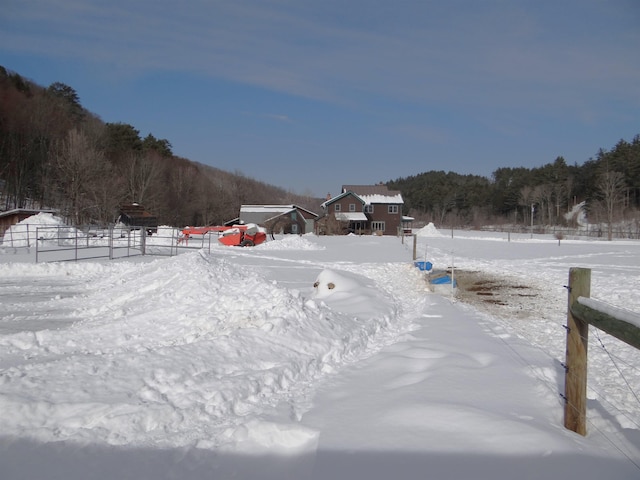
[388,135,640,232]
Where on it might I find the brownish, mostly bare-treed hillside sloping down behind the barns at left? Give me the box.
[0,66,322,226]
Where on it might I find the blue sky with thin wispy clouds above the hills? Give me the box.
[0,0,640,197]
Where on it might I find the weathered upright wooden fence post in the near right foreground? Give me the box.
[564,267,591,435]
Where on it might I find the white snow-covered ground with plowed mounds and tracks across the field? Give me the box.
[0,219,640,480]
